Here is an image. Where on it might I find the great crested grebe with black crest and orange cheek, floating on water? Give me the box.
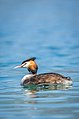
[15,57,72,86]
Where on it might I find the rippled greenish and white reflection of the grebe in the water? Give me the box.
[23,84,72,98]
